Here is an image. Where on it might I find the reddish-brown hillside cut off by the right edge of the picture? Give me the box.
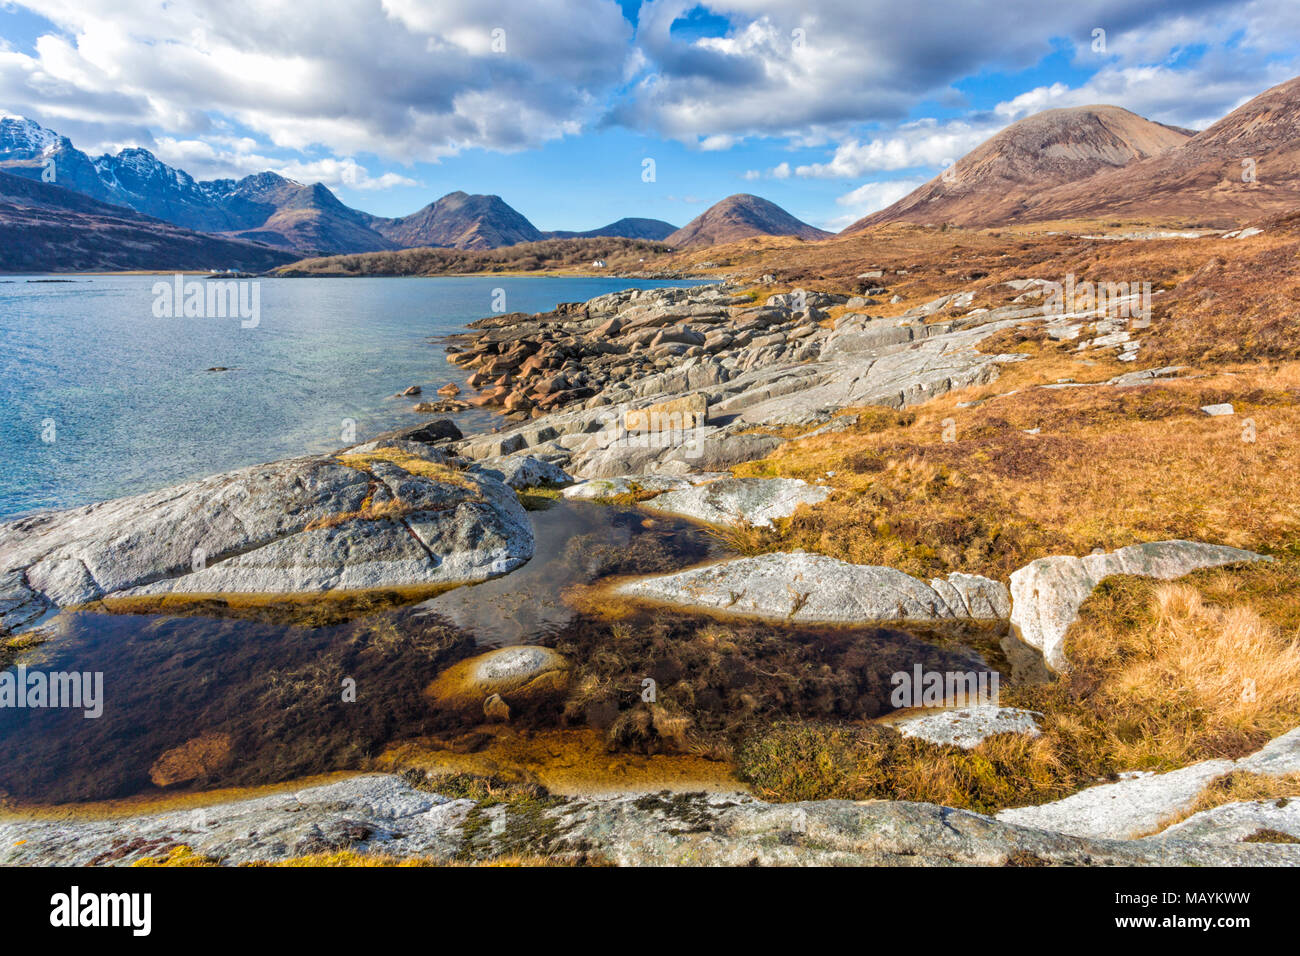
[1026,77,1300,228]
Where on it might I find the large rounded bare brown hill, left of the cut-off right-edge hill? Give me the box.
[844,107,1191,234]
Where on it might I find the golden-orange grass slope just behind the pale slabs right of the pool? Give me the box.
[735,354,1300,578]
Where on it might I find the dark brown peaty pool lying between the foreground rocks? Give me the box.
[0,501,1006,803]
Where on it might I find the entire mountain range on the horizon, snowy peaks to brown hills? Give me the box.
[0,70,1300,269]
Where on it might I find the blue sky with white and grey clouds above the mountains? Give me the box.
[0,0,1300,230]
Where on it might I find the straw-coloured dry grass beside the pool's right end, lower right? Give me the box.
[738,567,1300,812]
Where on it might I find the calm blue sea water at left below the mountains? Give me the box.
[0,276,707,518]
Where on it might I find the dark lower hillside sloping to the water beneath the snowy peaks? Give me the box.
[0,172,293,272]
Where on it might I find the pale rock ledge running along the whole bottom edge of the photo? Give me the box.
[10,731,1300,866]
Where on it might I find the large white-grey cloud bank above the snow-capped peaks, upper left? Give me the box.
[0,0,632,161]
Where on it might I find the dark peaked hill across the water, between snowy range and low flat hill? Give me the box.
[369,193,542,248]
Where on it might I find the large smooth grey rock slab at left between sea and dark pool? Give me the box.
[0,442,533,632]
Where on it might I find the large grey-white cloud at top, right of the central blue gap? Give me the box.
[607,0,1248,143]
